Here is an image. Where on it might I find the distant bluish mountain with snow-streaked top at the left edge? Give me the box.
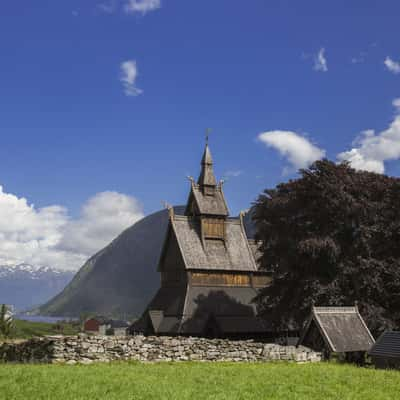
[0,264,74,311]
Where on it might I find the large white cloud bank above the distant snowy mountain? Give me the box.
[0,186,143,269]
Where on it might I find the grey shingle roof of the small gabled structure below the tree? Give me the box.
[299,307,375,353]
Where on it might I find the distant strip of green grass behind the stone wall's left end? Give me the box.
[7,320,79,340]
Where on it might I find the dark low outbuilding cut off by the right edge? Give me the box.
[368,331,400,369]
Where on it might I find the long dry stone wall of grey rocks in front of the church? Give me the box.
[0,335,322,364]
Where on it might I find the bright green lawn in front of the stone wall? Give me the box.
[0,362,400,400]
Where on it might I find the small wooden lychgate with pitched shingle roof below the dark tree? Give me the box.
[298,305,375,359]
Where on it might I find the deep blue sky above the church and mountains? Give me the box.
[0,0,400,268]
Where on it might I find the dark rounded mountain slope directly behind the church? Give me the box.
[37,206,252,318]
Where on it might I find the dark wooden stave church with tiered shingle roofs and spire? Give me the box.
[130,144,270,338]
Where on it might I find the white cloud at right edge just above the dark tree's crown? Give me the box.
[337,98,400,174]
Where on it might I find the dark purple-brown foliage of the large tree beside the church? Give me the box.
[253,160,400,334]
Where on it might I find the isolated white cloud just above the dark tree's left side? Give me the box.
[258,131,325,169]
